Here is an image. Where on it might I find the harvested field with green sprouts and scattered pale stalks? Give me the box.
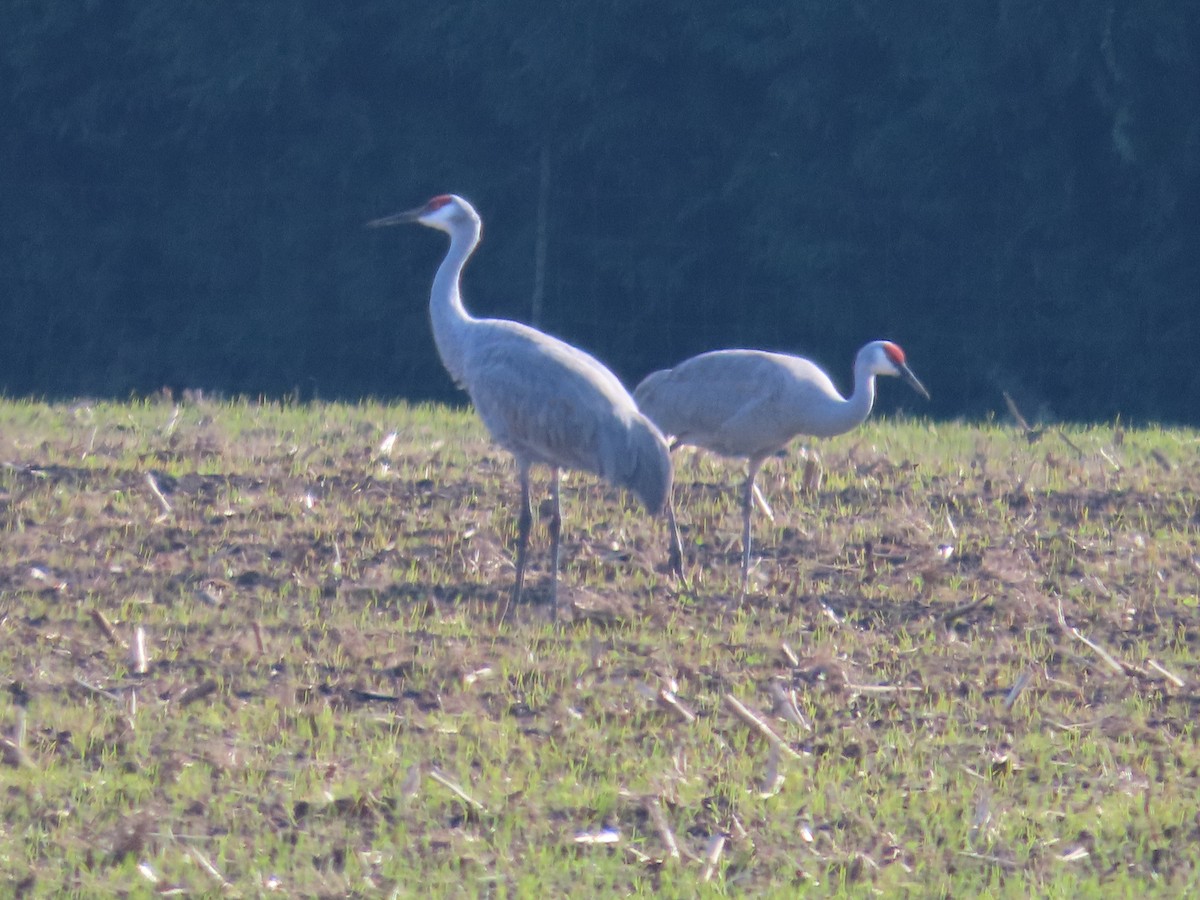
[0,398,1200,898]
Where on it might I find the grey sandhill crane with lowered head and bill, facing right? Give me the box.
[634,341,929,593]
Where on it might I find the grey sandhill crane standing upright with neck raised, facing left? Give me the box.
[367,194,671,618]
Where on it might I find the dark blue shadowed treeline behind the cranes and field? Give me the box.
[0,0,1200,424]
